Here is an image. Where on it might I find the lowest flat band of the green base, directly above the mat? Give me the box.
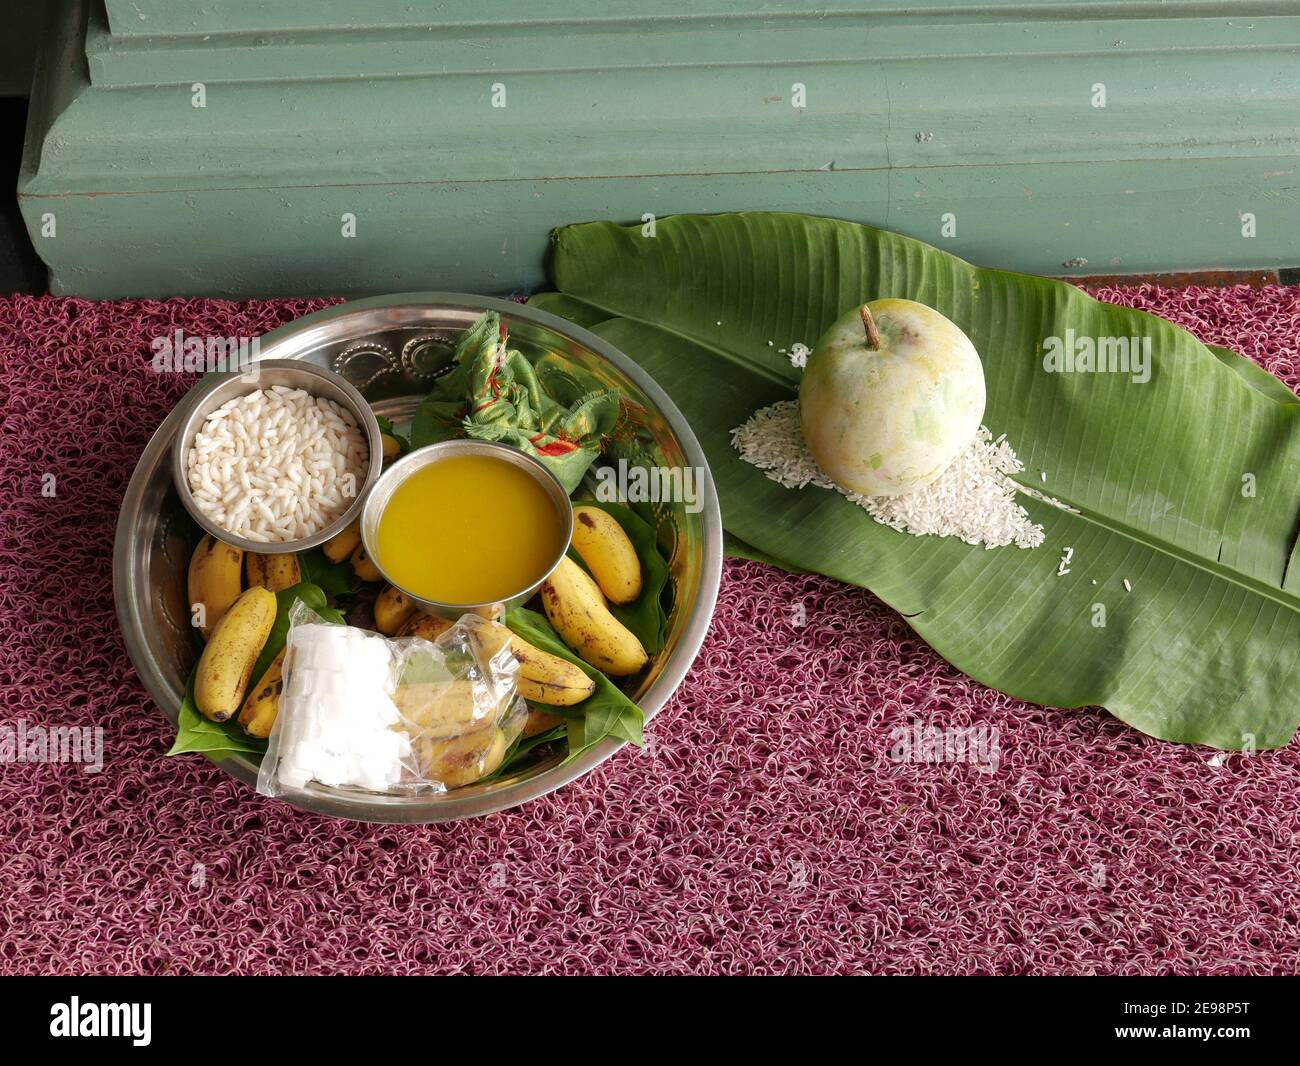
[29,160,1295,298]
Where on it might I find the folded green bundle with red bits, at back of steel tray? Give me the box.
[411,311,619,493]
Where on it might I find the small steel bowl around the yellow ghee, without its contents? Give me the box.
[361,439,573,619]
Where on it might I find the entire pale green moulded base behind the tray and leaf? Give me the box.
[20,0,1300,296]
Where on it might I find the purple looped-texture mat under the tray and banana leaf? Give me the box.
[0,286,1300,974]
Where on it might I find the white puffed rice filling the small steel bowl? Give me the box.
[186,385,371,543]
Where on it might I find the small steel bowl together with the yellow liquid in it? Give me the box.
[361,439,573,618]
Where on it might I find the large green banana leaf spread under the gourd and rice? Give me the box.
[533,213,1300,750]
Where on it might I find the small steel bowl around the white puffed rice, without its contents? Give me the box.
[172,359,384,555]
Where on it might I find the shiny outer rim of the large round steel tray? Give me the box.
[113,293,723,824]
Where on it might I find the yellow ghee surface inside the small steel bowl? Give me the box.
[376,455,564,603]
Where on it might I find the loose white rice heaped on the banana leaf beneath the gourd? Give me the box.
[732,400,1043,547]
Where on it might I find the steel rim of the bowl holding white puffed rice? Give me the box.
[172,361,384,555]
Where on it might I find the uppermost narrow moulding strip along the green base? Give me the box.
[86,8,1300,90]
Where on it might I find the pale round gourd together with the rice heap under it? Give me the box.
[732,300,1045,549]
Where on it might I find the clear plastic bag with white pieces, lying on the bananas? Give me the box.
[257,602,528,796]
